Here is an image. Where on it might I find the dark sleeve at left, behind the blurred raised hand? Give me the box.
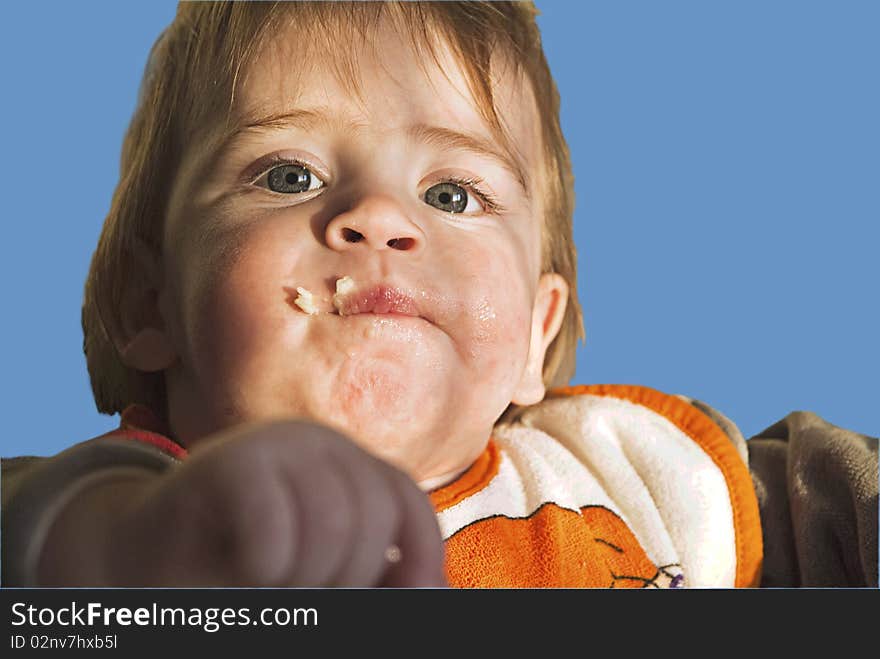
[0,438,177,587]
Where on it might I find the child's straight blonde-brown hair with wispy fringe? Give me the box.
[82,2,584,414]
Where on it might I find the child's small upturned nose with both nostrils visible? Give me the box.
[326,195,424,252]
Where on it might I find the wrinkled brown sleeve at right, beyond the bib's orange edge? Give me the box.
[746,412,878,587]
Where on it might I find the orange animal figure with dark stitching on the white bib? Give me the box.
[446,503,670,588]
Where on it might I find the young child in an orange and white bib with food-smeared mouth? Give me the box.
[3,3,877,587]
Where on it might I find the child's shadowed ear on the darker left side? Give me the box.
[113,240,177,373]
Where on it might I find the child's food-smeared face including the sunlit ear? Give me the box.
[135,19,567,480]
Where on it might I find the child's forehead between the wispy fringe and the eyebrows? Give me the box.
[231,14,540,196]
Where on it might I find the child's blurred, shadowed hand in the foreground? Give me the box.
[39,421,445,586]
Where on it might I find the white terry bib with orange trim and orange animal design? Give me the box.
[431,385,762,588]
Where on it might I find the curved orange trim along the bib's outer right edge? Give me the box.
[548,384,764,587]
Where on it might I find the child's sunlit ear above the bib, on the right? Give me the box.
[511,272,568,405]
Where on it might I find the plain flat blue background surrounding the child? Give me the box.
[0,0,880,456]
